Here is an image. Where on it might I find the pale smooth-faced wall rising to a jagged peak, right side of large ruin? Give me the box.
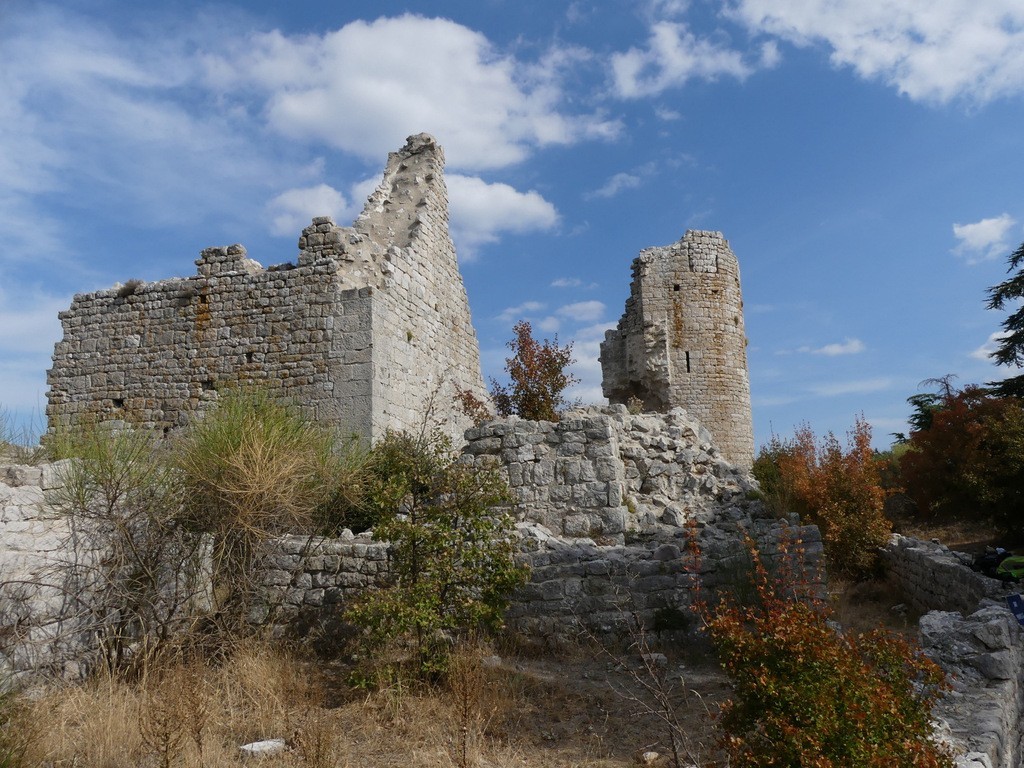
[354,134,487,443]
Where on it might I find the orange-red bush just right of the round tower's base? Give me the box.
[754,418,892,578]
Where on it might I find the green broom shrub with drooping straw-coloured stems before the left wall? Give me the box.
[173,389,362,621]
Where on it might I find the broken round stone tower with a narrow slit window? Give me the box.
[601,230,754,468]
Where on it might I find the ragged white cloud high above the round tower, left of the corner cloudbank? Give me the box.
[611,20,752,98]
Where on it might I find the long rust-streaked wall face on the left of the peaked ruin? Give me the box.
[47,246,373,435]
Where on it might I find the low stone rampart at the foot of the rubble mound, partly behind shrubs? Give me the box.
[256,518,821,648]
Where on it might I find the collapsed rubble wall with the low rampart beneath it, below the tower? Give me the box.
[258,406,823,647]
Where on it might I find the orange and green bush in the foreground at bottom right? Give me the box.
[698,542,952,768]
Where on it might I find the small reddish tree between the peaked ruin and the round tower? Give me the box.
[490,321,580,421]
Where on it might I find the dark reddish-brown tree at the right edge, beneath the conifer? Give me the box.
[899,383,1024,531]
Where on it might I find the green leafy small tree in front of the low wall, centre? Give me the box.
[346,432,526,679]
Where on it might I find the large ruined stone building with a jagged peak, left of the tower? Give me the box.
[46,134,486,441]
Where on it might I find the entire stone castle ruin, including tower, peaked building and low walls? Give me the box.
[0,134,1024,768]
